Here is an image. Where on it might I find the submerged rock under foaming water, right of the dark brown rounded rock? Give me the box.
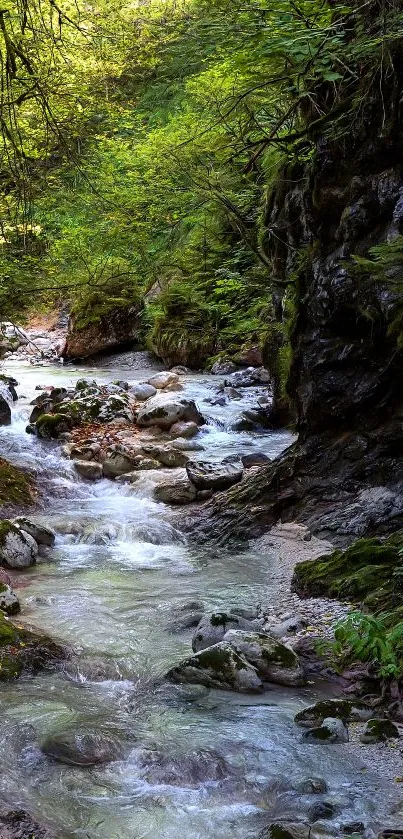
[138,749,231,788]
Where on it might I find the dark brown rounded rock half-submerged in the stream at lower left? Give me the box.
[42,731,123,767]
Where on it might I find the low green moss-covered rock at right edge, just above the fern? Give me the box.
[292,532,403,612]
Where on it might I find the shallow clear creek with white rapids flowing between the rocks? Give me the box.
[0,364,395,839]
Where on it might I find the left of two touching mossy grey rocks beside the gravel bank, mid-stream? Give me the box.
[167,642,263,693]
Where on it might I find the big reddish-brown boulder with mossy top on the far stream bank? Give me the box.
[61,305,140,359]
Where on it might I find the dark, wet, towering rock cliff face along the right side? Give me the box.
[197,63,403,543]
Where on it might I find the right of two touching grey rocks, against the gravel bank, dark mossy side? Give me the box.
[224,629,306,687]
